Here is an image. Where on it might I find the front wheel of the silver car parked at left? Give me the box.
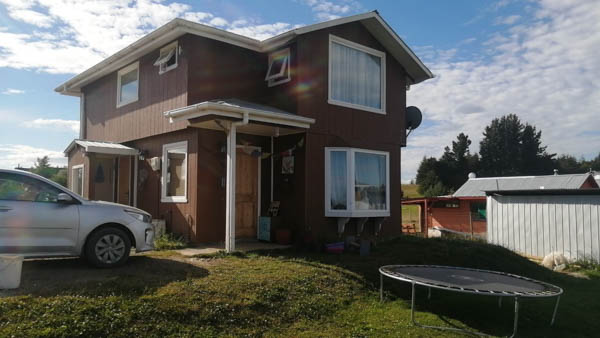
[85,227,131,268]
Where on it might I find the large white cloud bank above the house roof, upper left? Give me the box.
[0,0,298,73]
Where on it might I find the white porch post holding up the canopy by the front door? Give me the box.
[225,123,237,252]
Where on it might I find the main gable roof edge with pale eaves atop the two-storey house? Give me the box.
[54,11,433,96]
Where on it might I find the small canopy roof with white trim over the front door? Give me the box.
[164,98,315,136]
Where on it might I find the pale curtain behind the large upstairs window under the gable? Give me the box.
[330,42,381,109]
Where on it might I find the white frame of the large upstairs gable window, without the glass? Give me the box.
[327,34,386,115]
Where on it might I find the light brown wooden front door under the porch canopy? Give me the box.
[235,149,259,238]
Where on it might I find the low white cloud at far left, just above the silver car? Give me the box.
[0,144,67,169]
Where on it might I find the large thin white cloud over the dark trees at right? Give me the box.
[402,0,600,181]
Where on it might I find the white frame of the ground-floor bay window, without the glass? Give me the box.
[325,147,391,217]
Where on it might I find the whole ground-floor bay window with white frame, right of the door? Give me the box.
[325,148,390,217]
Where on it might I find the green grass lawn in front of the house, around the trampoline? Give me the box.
[0,236,600,337]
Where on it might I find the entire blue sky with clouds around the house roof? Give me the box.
[0,0,600,181]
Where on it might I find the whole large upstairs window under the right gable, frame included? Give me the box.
[328,35,385,114]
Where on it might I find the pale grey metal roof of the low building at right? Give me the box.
[452,173,593,197]
